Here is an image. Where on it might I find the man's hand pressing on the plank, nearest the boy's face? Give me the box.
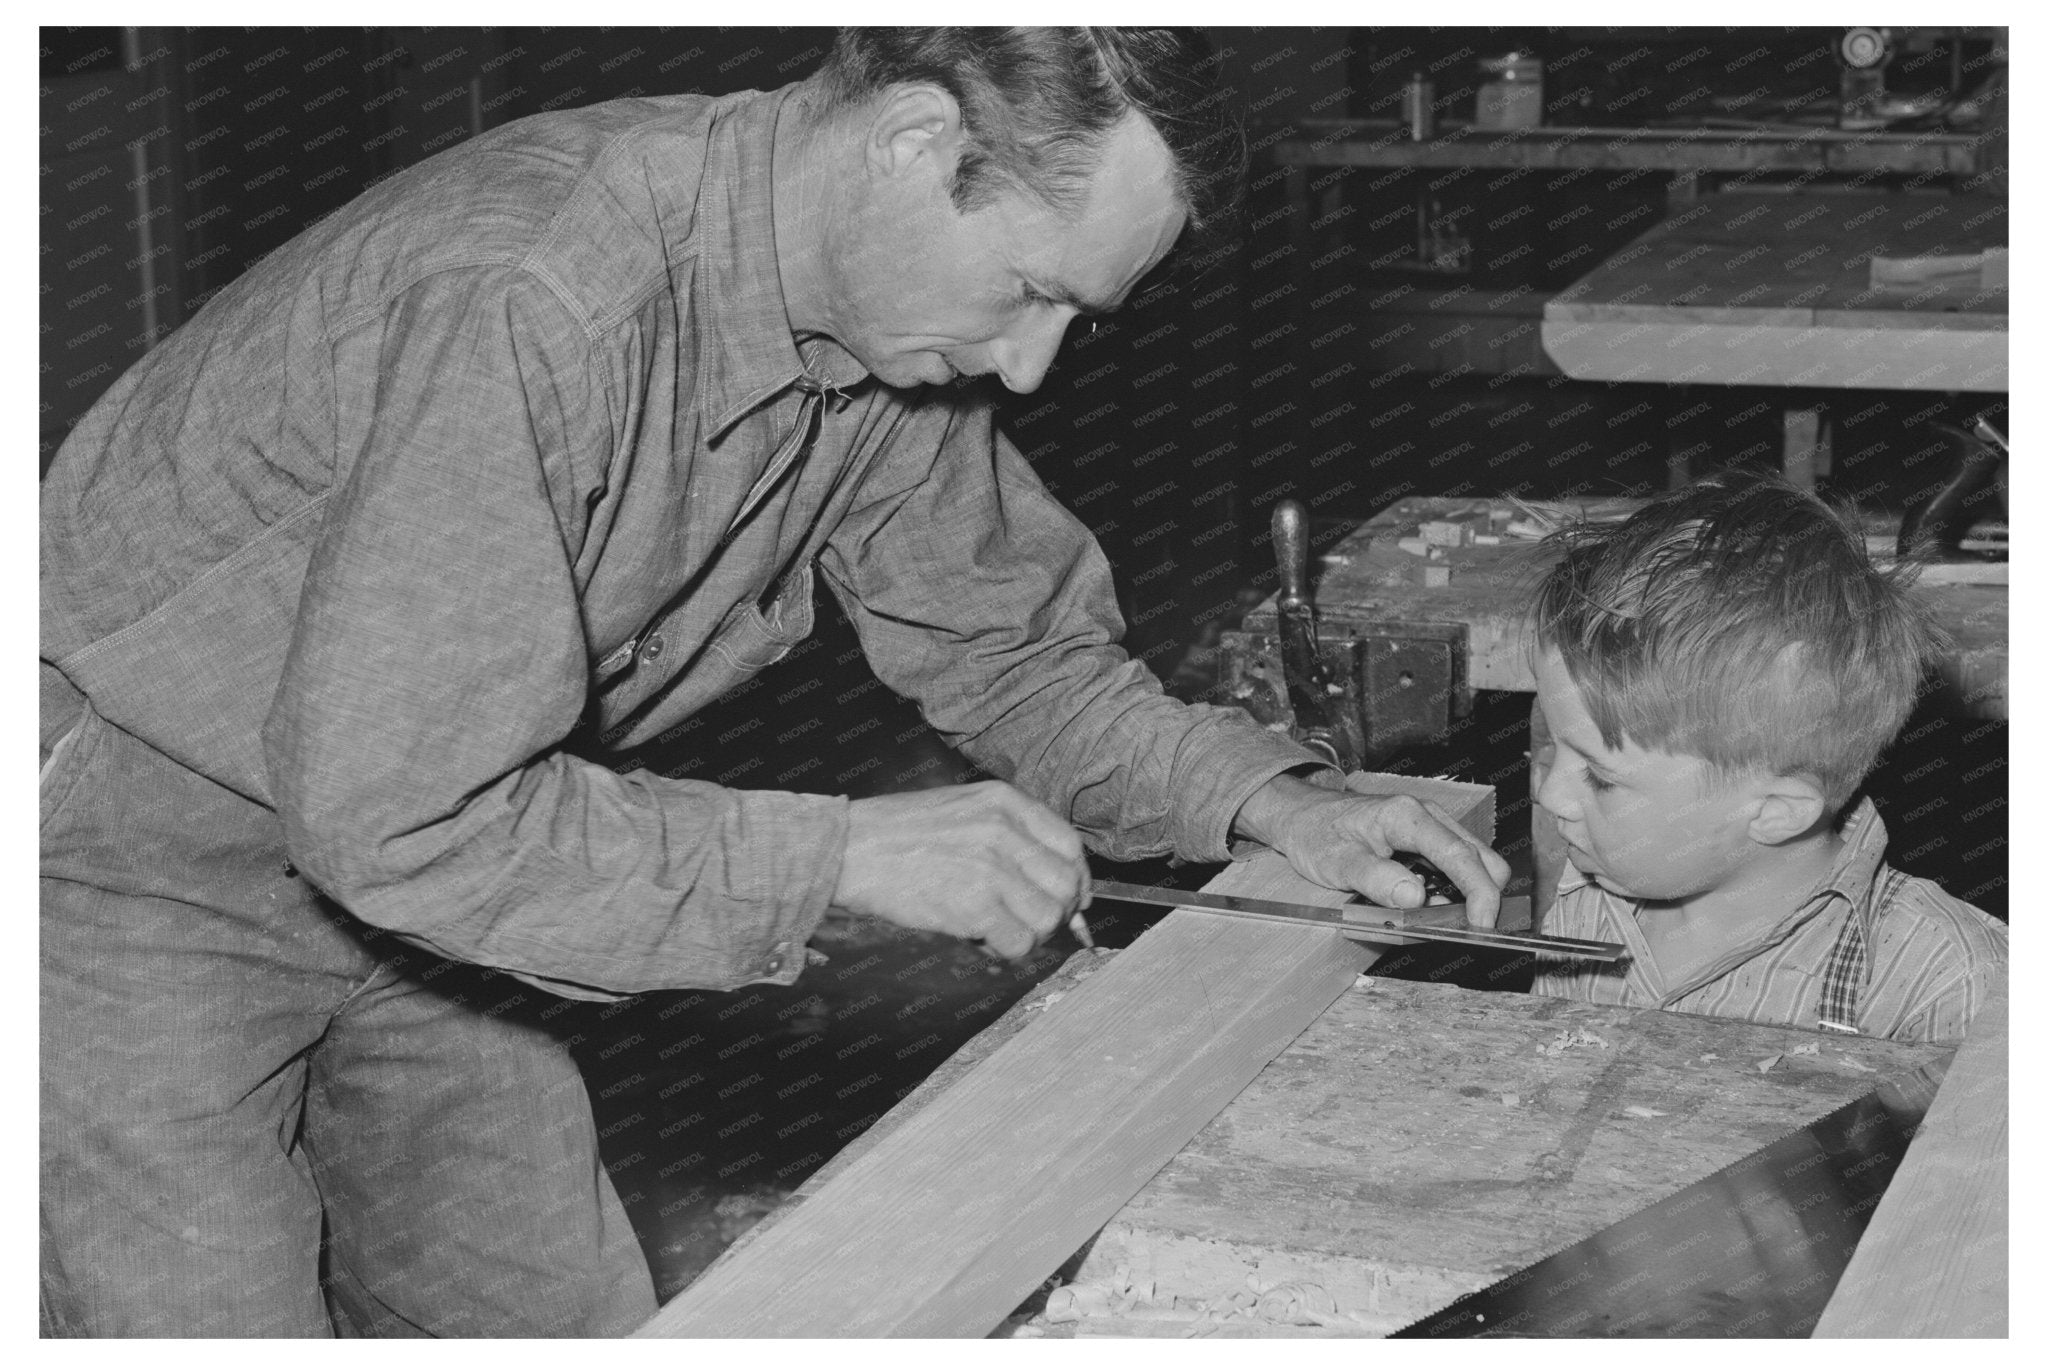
[1237,774,1507,929]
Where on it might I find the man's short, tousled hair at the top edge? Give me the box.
[819,29,1245,252]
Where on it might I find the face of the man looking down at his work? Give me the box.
[831,117,1186,393]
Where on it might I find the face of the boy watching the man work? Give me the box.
[1536,651,1759,900]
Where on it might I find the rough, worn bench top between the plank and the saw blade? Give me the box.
[1067,978,1948,1334]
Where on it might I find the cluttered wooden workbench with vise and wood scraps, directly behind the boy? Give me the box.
[1245,497,2011,720]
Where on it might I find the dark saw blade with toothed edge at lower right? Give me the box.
[1395,1056,1950,1338]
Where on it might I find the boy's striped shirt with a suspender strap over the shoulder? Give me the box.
[1534,798,2007,1042]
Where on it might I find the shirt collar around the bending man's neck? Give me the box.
[694,86,868,440]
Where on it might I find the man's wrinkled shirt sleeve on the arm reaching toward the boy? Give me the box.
[821,403,1317,862]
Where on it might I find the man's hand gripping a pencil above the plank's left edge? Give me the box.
[831,782,1087,958]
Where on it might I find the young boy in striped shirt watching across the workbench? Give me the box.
[1532,475,2007,1042]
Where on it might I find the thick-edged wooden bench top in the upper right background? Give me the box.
[1542,192,2007,393]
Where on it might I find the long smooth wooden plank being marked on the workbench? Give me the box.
[635,774,1493,1336]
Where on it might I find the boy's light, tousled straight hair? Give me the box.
[1536,471,1942,814]
